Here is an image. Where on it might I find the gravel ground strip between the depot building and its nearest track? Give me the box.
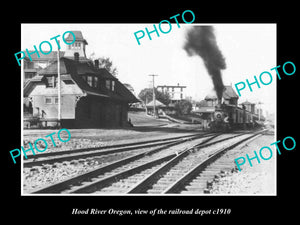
[22,119,203,154]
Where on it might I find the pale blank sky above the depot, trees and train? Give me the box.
[20,23,277,113]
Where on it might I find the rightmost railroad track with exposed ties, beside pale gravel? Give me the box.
[127,132,261,194]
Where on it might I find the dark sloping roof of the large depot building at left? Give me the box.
[24,57,139,103]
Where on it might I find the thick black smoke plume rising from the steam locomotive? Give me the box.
[184,26,226,100]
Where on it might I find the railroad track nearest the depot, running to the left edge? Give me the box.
[23,133,212,168]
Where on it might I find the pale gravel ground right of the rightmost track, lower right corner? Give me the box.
[210,135,277,195]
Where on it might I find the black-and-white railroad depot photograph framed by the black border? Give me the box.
[20,22,276,195]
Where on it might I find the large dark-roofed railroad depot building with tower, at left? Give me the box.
[23,31,138,128]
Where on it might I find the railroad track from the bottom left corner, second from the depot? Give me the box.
[33,134,219,193]
